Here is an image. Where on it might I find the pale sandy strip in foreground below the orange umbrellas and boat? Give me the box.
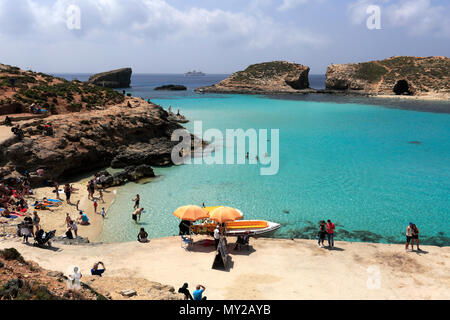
[0,237,450,300]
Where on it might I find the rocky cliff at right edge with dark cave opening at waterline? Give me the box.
[326,57,450,96]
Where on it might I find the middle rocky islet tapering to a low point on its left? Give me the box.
[196,61,309,94]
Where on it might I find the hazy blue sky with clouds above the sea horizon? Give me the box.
[0,0,450,74]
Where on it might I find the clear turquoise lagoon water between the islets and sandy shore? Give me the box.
[101,95,450,245]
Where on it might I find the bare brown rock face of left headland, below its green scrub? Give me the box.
[0,98,192,183]
